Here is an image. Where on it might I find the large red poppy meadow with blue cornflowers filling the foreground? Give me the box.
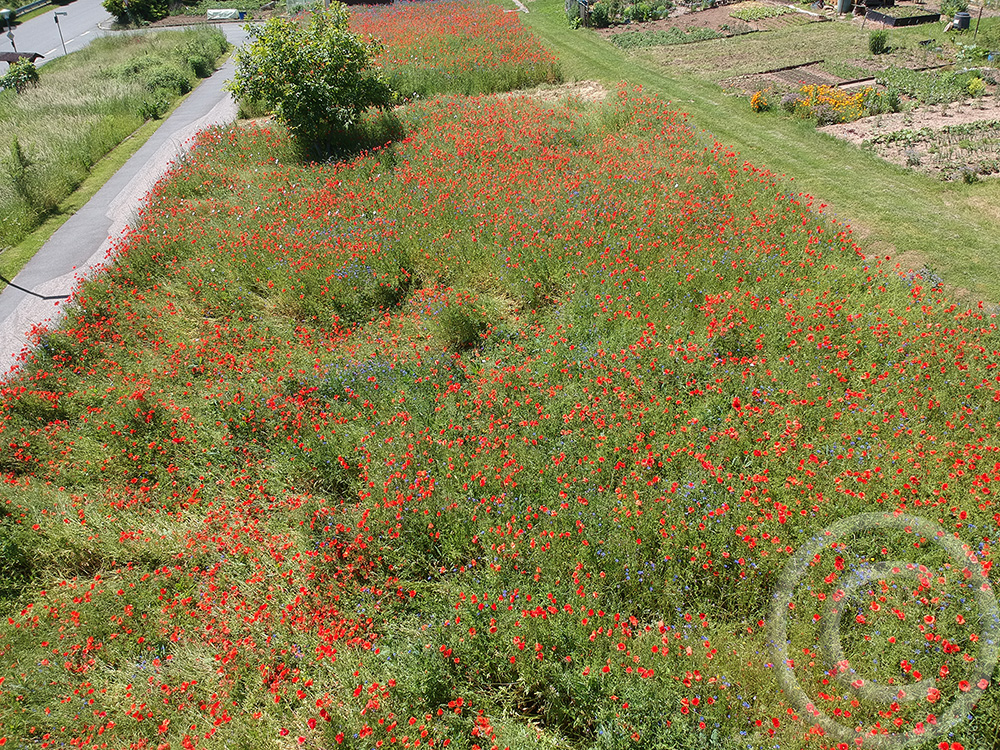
[0,3,1000,750]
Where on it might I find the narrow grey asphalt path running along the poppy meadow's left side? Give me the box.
[0,20,246,381]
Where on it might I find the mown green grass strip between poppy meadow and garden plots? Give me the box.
[525,0,1000,302]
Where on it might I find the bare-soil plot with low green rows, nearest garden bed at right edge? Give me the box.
[820,97,1000,181]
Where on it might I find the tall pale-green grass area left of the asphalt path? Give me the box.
[0,29,227,249]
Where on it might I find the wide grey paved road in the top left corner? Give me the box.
[0,0,111,68]
